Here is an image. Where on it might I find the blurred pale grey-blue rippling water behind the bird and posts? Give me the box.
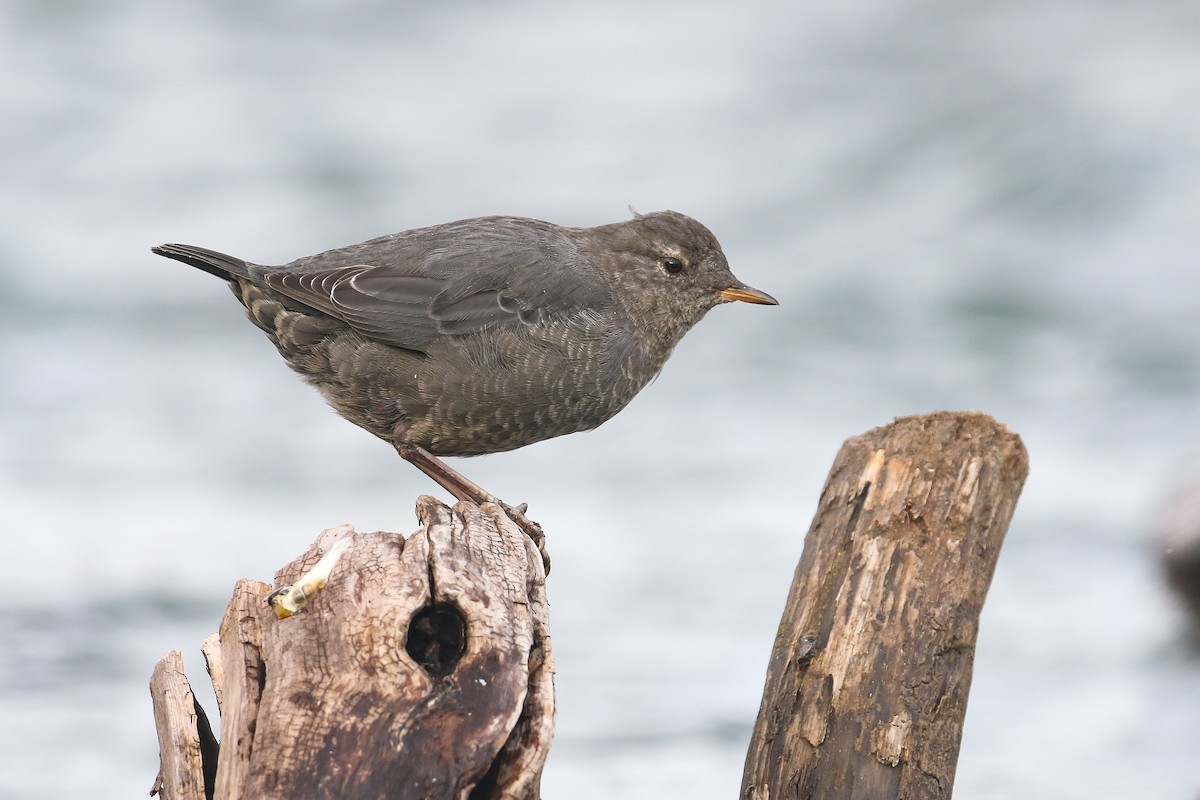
[0,0,1200,800]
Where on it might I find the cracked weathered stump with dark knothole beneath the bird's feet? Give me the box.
[146,497,554,800]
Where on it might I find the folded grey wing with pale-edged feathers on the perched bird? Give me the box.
[259,226,601,350]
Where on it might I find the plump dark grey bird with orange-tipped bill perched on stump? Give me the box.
[154,211,778,551]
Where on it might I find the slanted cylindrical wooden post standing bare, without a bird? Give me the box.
[742,413,1028,800]
